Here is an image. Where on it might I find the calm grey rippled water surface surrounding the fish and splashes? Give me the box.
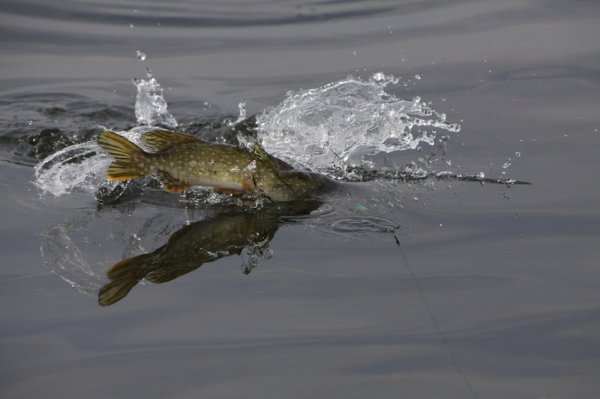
[0,0,600,399]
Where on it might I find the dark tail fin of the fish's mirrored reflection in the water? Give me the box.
[98,254,147,306]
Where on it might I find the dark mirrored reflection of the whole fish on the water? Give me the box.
[98,200,320,306]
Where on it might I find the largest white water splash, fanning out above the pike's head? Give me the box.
[257,72,460,173]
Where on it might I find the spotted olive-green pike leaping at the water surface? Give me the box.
[98,129,329,201]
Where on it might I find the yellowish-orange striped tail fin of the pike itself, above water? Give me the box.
[98,131,148,180]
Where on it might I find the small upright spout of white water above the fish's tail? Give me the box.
[132,69,178,128]
